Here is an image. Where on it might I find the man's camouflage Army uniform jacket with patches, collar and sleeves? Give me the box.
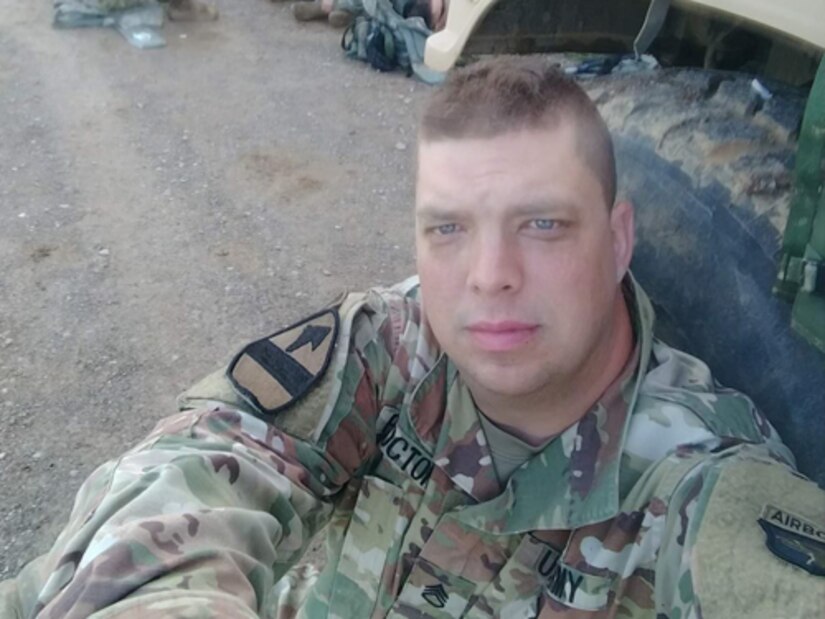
[0,281,825,619]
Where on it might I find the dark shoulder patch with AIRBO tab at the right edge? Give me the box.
[759,505,825,576]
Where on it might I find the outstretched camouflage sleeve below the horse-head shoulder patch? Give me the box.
[2,409,349,619]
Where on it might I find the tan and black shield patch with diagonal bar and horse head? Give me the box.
[226,309,339,415]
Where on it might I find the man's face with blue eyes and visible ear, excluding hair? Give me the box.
[416,122,633,397]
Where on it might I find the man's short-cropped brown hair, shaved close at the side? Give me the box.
[420,56,616,206]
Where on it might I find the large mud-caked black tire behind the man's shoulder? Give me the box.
[583,69,825,487]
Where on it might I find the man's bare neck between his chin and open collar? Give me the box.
[468,291,633,445]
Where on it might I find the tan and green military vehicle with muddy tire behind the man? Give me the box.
[425,0,825,487]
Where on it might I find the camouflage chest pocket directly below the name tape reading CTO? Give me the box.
[330,475,423,619]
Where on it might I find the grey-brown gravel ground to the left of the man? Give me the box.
[0,0,429,579]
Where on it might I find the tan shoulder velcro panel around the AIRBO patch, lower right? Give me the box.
[691,459,825,619]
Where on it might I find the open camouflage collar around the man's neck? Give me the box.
[411,275,654,534]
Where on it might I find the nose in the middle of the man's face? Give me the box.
[468,235,523,296]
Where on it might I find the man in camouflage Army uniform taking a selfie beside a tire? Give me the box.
[0,59,825,619]
